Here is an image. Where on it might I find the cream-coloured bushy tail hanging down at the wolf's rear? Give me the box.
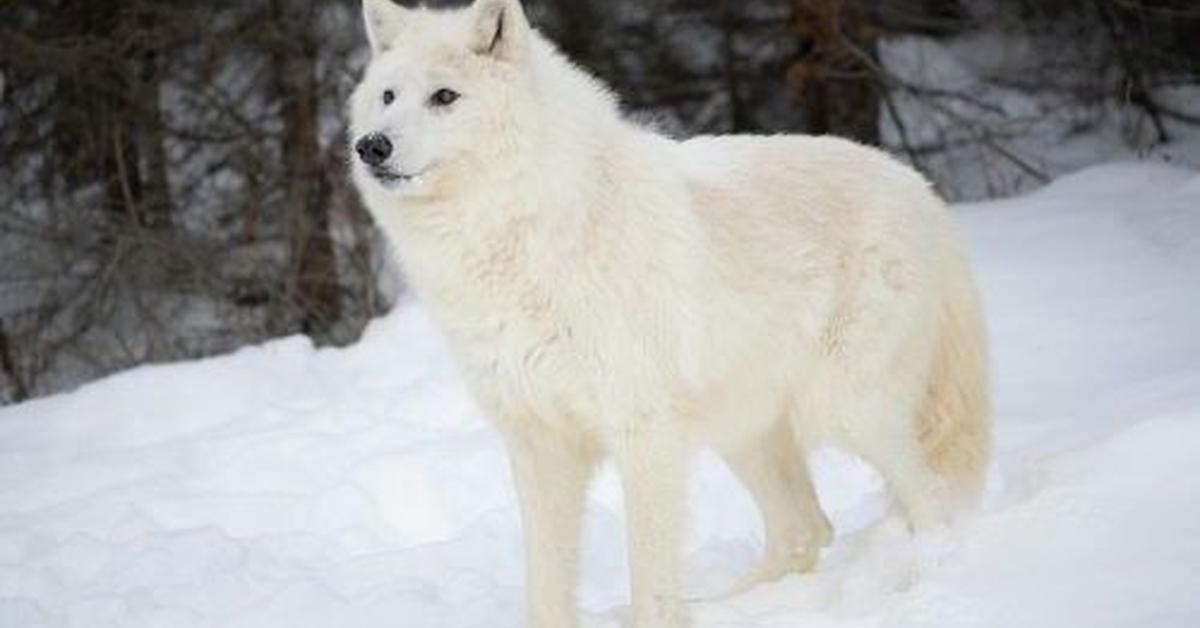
[917,261,991,501]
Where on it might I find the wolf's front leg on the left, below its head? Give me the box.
[505,426,598,628]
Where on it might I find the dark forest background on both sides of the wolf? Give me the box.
[0,0,1200,403]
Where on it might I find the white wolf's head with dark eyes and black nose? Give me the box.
[350,0,535,204]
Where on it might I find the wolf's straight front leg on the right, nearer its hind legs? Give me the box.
[614,425,688,628]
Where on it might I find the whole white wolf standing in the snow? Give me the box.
[350,0,989,628]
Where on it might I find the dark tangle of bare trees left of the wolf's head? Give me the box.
[0,0,390,399]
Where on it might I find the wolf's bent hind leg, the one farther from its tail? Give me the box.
[724,420,833,592]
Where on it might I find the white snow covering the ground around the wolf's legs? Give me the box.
[0,165,1200,628]
